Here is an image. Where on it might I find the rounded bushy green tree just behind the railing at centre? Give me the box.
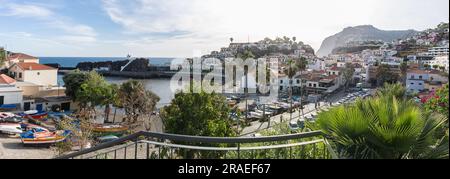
[161,89,236,137]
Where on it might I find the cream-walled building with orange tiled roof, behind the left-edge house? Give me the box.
[9,63,58,87]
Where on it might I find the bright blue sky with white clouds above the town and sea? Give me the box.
[0,0,449,57]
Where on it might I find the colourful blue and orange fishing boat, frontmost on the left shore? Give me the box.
[20,128,71,145]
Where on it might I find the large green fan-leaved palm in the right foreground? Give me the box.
[317,97,449,159]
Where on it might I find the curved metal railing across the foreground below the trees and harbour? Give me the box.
[56,131,337,159]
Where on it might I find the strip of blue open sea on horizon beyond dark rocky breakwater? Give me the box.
[39,57,175,67]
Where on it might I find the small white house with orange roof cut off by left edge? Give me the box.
[0,74,23,109]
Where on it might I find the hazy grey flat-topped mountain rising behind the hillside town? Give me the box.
[317,25,418,57]
